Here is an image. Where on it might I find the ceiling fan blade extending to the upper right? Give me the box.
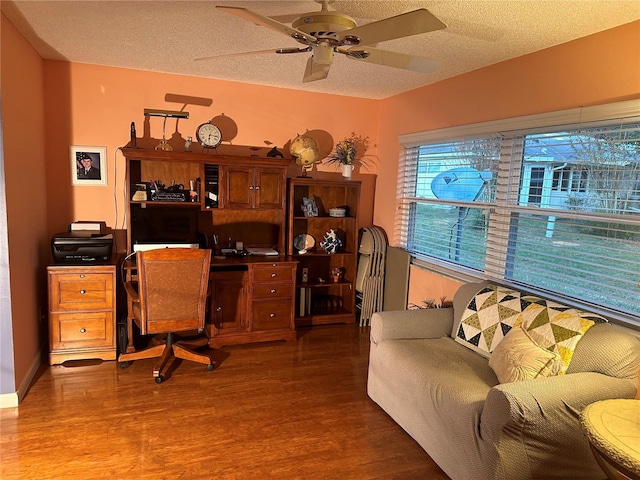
[337,8,447,45]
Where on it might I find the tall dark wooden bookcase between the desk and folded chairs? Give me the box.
[287,177,361,325]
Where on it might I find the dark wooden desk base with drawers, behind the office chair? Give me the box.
[124,255,298,353]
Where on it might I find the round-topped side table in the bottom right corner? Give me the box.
[580,399,640,480]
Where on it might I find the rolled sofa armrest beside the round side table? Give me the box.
[480,372,637,445]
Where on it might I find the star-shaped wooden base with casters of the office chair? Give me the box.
[118,333,215,383]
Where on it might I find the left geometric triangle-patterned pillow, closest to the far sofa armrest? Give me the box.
[455,285,522,358]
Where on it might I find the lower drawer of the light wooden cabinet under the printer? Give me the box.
[49,312,115,349]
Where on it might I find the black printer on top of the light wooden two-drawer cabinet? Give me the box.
[51,223,113,263]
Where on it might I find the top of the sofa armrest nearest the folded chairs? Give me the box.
[371,308,453,344]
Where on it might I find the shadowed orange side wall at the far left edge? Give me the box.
[0,15,48,393]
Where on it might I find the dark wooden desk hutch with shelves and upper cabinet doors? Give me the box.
[123,147,290,252]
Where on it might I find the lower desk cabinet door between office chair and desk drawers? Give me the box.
[211,272,248,336]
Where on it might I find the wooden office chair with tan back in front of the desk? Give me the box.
[118,248,214,383]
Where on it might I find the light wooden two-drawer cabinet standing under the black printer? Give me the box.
[47,263,116,365]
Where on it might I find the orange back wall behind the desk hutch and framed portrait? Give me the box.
[44,61,378,239]
